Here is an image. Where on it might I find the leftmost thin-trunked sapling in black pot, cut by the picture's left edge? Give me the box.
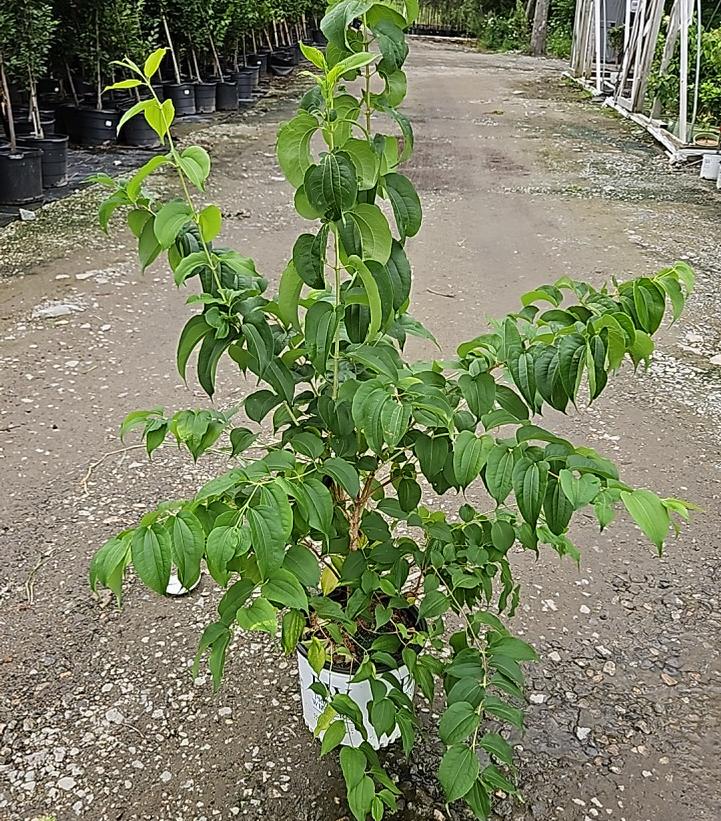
[0,5,43,205]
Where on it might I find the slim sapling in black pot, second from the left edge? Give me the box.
[7,0,68,188]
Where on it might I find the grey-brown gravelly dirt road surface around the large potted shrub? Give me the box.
[0,41,721,821]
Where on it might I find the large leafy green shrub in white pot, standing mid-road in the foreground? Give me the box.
[90,0,693,821]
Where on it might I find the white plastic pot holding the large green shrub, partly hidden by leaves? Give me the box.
[297,650,416,750]
